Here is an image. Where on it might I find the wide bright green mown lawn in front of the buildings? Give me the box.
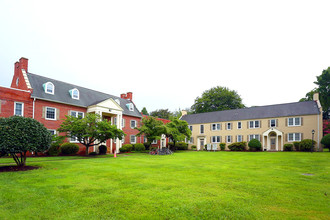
[0,152,330,219]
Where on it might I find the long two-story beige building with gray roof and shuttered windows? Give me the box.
[181,94,323,151]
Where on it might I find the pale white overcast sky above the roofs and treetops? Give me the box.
[0,0,330,112]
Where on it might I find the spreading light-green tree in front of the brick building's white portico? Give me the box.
[58,113,125,155]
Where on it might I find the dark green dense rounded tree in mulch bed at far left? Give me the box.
[0,116,52,166]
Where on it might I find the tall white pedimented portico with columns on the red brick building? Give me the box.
[87,98,123,153]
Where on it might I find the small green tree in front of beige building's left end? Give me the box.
[163,118,191,150]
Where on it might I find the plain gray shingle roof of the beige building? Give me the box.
[181,101,320,124]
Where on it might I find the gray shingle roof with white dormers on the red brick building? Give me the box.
[27,73,142,118]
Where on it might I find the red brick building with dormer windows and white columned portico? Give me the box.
[0,57,144,153]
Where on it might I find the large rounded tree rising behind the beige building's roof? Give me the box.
[191,86,245,113]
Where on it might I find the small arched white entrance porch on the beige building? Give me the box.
[262,128,283,151]
